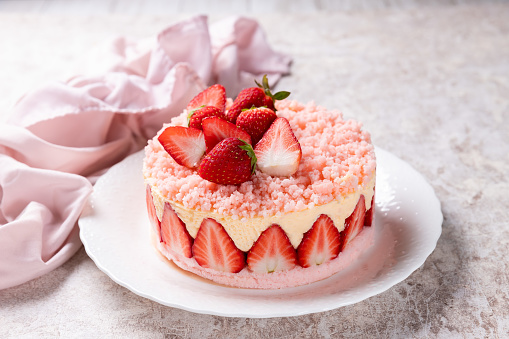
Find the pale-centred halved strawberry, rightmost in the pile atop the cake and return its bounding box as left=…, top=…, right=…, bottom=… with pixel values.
left=254, top=118, right=302, bottom=176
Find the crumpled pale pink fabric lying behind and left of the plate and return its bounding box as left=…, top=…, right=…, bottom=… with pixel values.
left=0, top=16, right=290, bottom=289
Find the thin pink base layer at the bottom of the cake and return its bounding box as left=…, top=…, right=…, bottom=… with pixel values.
left=157, top=225, right=375, bottom=289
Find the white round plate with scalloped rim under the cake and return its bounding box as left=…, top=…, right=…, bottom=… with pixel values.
left=79, top=148, right=443, bottom=318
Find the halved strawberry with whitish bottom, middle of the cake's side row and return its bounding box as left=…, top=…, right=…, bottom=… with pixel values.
left=247, top=224, right=297, bottom=273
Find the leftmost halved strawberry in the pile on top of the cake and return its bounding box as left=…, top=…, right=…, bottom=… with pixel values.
left=158, top=126, right=206, bottom=168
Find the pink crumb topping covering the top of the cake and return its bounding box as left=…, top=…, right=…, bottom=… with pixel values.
left=144, top=100, right=376, bottom=218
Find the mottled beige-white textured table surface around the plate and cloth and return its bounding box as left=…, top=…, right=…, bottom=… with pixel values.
left=0, top=2, right=509, bottom=338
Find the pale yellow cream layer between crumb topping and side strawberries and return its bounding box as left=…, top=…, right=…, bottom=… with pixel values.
left=152, top=175, right=375, bottom=252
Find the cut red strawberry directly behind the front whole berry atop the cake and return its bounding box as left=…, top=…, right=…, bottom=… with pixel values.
left=202, top=117, right=251, bottom=153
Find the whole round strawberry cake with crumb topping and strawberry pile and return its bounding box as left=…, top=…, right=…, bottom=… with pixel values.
left=143, top=77, right=376, bottom=289
